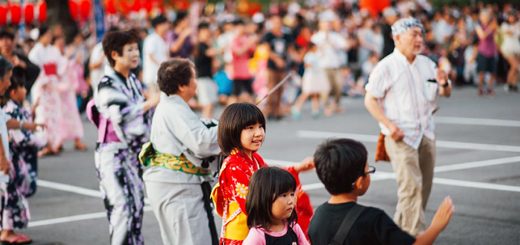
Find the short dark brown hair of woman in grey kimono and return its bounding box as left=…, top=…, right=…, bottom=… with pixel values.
left=157, top=58, right=195, bottom=95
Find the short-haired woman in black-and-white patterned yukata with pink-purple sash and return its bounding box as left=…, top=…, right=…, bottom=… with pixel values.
left=91, top=31, right=159, bottom=244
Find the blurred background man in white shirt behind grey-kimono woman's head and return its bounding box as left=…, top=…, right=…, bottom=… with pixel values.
left=143, top=15, right=170, bottom=92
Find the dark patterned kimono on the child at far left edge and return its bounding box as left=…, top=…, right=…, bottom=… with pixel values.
left=3, top=100, right=39, bottom=197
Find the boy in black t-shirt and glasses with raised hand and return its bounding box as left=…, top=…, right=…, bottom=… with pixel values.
left=309, top=139, right=454, bottom=245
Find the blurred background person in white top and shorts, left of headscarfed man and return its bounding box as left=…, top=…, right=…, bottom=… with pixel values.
left=311, top=11, right=347, bottom=115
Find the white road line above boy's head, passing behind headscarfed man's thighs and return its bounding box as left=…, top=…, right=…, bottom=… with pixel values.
left=297, top=130, right=520, bottom=152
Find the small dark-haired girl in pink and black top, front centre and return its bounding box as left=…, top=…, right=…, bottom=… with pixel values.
left=242, top=167, right=310, bottom=245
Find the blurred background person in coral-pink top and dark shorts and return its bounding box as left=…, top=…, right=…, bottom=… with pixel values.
left=229, top=19, right=257, bottom=104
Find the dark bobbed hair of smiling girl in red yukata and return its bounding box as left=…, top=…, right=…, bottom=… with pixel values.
left=218, top=103, right=266, bottom=155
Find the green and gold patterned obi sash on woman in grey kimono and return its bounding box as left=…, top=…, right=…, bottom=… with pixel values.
left=139, top=142, right=211, bottom=176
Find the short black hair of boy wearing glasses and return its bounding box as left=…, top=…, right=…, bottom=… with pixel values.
left=314, top=139, right=368, bottom=195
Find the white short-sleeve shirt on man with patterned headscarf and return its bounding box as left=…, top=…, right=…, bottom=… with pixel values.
left=366, top=49, right=439, bottom=149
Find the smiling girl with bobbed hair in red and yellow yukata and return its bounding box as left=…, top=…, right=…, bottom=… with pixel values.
left=212, top=103, right=314, bottom=244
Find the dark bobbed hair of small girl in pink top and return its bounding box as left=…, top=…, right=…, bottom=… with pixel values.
left=246, top=167, right=298, bottom=229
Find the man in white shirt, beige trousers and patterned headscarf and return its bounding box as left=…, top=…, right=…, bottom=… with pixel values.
left=365, top=18, right=451, bottom=236
